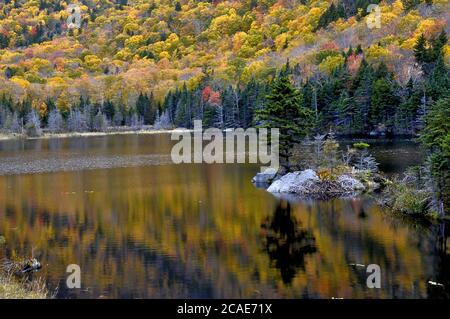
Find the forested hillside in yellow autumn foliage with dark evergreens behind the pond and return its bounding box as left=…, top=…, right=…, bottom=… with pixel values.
left=0, top=0, right=450, bottom=134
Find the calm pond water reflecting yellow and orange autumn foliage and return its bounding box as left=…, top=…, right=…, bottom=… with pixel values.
left=0, top=135, right=449, bottom=298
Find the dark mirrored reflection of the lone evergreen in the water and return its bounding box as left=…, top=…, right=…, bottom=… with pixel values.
left=261, top=200, right=317, bottom=284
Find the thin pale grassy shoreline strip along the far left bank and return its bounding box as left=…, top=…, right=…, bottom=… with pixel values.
left=0, top=128, right=191, bottom=141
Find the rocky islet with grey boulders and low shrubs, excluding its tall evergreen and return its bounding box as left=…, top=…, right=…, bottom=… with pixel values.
left=253, top=138, right=388, bottom=200
